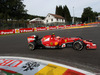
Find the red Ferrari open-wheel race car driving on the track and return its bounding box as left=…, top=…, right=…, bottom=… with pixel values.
left=27, top=35, right=97, bottom=51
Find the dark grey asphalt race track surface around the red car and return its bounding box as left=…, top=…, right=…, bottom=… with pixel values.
left=0, top=25, right=100, bottom=73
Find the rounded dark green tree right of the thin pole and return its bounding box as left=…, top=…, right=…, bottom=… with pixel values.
left=81, top=7, right=95, bottom=23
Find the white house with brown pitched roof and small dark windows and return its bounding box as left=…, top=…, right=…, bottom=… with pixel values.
left=44, top=13, right=65, bottom=24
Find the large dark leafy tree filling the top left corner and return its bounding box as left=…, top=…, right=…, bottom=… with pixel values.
left=0, top=0, right=27, bottom=20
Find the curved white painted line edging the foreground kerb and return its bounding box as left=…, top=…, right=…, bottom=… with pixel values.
left=0, top=56, right=95, bottom=75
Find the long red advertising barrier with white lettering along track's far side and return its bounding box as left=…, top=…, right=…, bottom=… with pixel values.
left=0, top=22, right=100, bottom=35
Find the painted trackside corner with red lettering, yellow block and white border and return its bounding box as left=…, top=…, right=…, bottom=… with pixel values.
left=0, top=56, right=94, bottom=75
